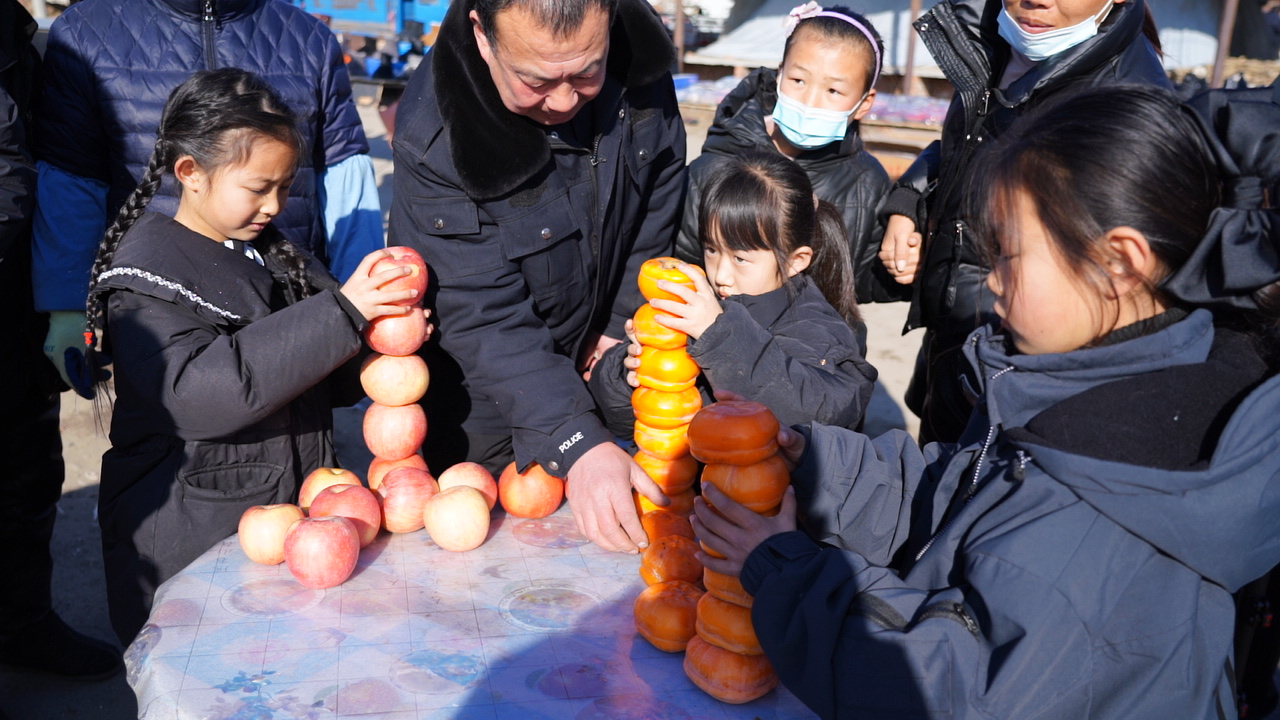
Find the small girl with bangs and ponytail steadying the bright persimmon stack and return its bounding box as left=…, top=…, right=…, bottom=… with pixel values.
left=590, top=151, right=876, bottom=437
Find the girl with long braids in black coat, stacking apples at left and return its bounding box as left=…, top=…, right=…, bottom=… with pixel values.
left=86, top=69, right=413, bottom=644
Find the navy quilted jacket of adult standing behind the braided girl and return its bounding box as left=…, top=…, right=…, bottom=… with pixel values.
left=38, top=0, right=369, bottom=259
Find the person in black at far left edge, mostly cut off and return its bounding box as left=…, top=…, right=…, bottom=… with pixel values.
left=0, top=0, right=122, bottom=681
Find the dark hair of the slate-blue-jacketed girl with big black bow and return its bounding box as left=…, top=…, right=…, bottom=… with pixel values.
left=969, top=86, right=1280, bottom=359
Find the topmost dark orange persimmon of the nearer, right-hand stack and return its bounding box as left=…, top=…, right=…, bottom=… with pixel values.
left=689, top=400, right=778, bottom=465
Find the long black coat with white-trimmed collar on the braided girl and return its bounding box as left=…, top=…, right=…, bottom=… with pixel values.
left=96, top=213, right=364, bottom=644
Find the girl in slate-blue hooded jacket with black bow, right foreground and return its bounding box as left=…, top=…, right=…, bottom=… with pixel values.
left=694, top=88, right=1280, bottom=720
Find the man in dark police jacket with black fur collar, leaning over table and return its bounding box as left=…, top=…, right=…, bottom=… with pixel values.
left=389, top=0, right=685, bottom=552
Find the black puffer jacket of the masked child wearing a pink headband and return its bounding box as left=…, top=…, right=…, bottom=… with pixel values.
left=676, top=68, right=910, bottom=302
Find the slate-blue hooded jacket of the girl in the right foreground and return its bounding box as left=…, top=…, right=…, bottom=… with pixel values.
left=742, top=310, right=1280, bottom=720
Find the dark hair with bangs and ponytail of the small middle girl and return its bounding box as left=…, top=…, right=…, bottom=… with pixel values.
left=698, top=149, right=861, bottom=325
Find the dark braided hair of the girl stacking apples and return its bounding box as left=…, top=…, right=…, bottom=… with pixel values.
left=84, top=68, right=311, bottom=345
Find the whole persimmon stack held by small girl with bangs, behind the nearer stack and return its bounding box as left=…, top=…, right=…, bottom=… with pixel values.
left=631, top=258, right=703, bottom=652
